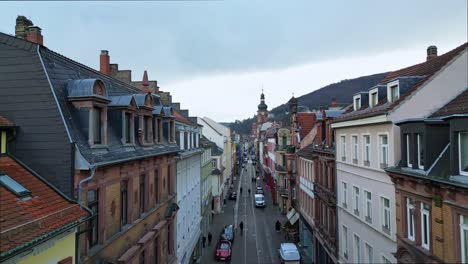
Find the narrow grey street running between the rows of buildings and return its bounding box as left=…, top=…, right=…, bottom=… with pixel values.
left=201, top=160, right=286, bottom=264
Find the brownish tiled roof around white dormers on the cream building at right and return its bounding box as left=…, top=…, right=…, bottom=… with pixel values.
left=334, top=42, right=468, bottom=123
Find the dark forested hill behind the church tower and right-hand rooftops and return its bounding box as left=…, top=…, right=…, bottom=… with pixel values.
left=228, top=73, right=387, bottom=135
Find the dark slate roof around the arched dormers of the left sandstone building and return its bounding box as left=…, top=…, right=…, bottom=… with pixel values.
left=0, top=33, right=179, bottom=164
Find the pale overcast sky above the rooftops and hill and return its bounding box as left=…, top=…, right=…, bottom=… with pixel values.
left=0, top=0, right=468, bottom=121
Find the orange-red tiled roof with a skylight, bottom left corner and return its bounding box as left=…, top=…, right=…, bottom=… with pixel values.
left=0, top=156, right=88, bottom=257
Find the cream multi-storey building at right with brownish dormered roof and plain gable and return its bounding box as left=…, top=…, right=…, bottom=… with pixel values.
left=332, top=44, right=467, bottom=263
